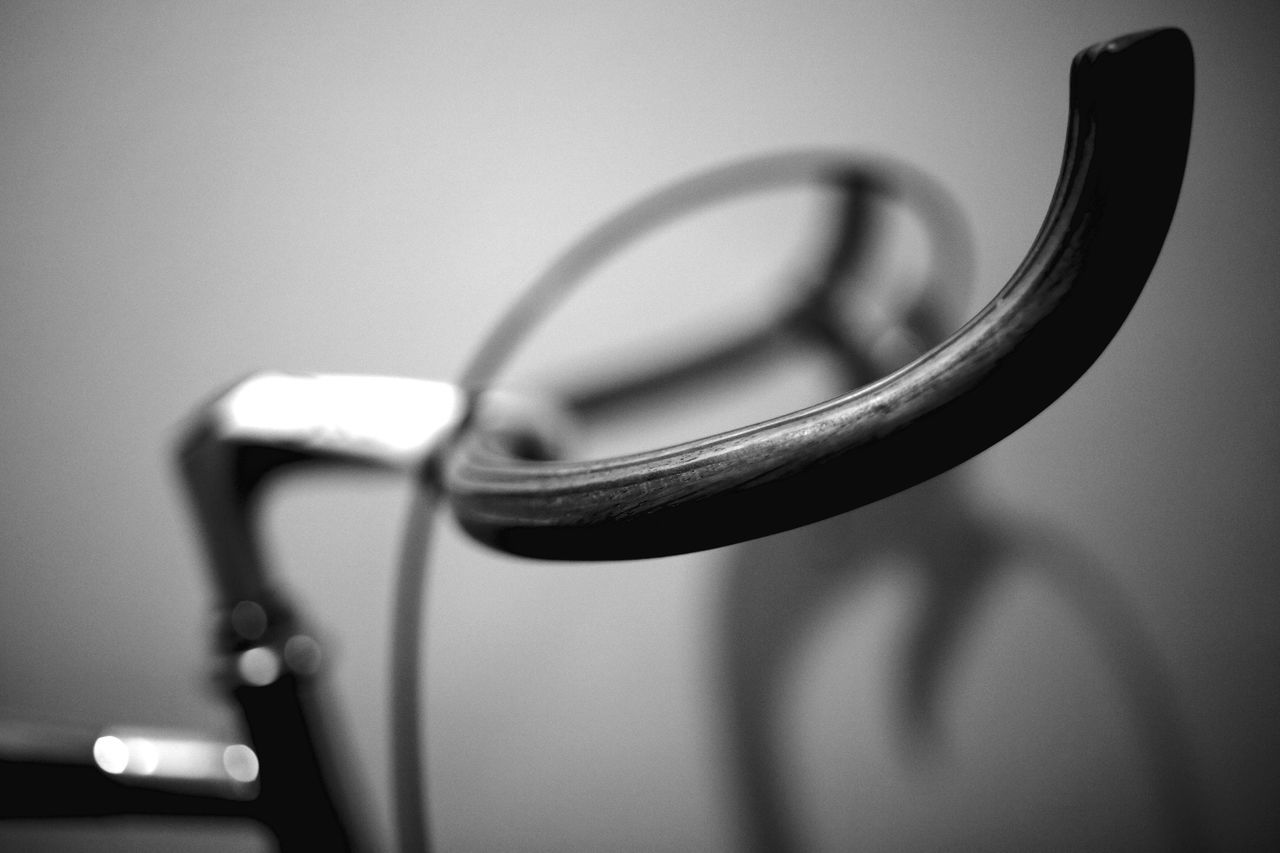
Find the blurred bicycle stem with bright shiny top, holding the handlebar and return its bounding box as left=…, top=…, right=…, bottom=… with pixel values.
left=177, top=371, right=564, bottom=610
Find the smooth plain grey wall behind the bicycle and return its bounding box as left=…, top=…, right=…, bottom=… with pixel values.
left=0, top=0, right=1280, bottom=850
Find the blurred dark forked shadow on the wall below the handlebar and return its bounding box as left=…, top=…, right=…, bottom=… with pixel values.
left=714, top=469, right=1208, bottom=853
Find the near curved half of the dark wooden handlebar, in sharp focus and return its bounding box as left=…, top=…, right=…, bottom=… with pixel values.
left=445, top=29, right=1194, bottom=560
